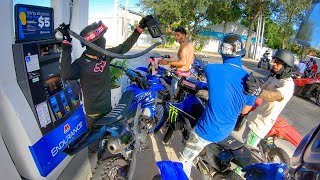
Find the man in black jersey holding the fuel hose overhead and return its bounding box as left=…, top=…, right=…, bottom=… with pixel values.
left=59, top=16, right=150, bottom=152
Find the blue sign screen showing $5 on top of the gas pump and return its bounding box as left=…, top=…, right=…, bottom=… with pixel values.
left=14, top=4, right=54, bottom=42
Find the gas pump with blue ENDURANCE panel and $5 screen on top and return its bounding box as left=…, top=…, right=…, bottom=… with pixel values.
left=4, top=4, right=86, bottom=179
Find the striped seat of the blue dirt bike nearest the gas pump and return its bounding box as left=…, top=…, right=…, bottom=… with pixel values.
left=94, top=91, right=134, bottom=126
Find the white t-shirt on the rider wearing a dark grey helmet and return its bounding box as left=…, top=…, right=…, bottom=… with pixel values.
left=247, top=76, right=294, bottom=138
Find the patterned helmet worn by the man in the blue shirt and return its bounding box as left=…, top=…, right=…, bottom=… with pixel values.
left=219, top=33, right=246, bottom=57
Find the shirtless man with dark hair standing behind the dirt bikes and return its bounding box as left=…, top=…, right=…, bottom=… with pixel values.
left=159, top=26, right=194, bottom=98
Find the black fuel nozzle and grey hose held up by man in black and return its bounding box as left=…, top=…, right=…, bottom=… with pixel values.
left=54, top=15, right=166, bottom=59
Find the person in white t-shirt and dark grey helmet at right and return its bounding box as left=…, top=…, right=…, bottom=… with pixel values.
left=242, top=49, right=294, bottom=147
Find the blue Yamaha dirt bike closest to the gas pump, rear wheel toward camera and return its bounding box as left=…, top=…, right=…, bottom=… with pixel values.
left=63, top=65, right=169, bottom=179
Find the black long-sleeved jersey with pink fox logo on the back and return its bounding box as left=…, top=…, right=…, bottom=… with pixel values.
left=61, top=30, right=140, bottom=114
